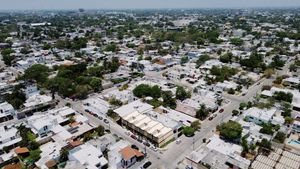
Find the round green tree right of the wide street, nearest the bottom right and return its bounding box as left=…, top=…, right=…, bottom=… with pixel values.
left=218, top=121, right=243, bottom=141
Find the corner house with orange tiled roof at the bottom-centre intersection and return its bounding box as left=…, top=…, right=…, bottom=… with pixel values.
left=120, top=146, right=144, bottom=168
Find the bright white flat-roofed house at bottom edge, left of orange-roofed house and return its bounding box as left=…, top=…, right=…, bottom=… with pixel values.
left=69, top=143, right=108, bottom=169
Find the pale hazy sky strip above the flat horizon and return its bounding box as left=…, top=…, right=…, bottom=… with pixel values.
left=0, top=0, right=300, bottom=10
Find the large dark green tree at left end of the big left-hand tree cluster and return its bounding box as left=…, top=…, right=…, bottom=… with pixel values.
left=23, top=64, right=49, bottom=83
